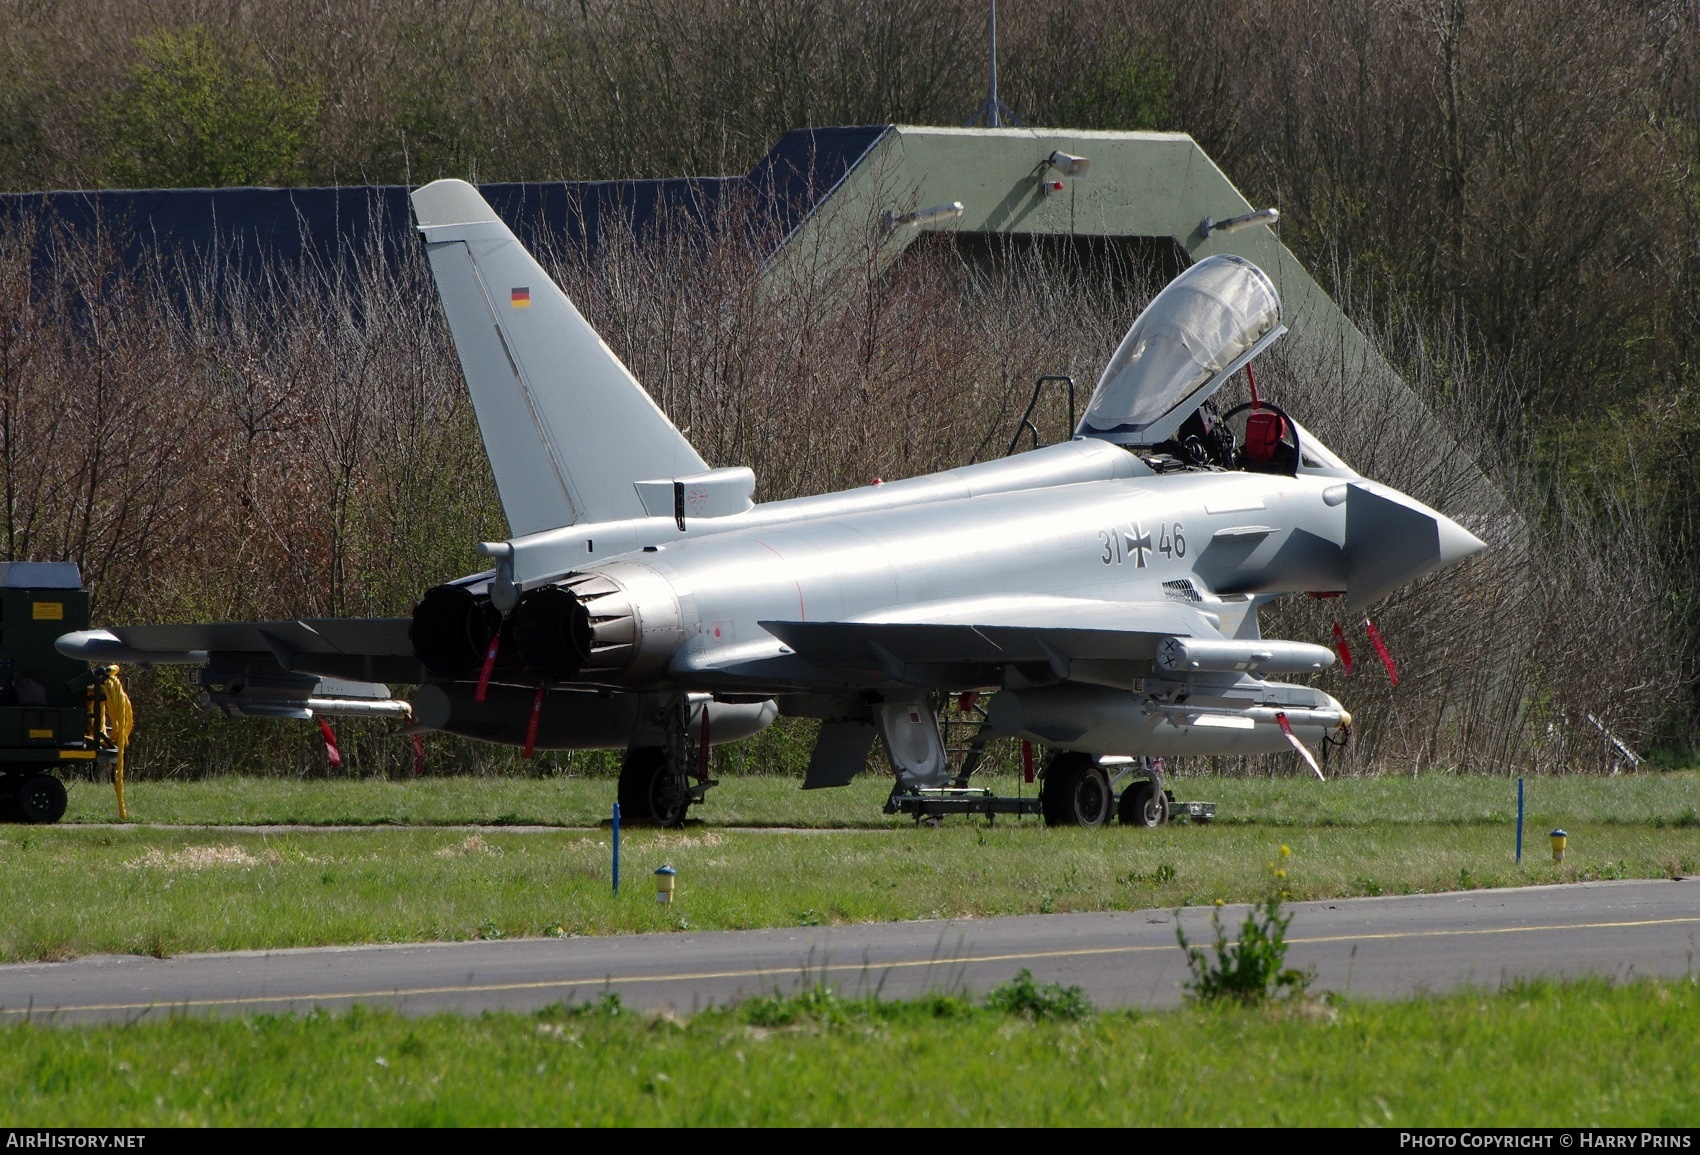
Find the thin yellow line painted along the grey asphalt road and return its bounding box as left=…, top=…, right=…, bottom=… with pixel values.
left=0, top=915, right=1700, bottom=1016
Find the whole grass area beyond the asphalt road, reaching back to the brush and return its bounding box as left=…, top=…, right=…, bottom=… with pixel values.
left=0, top=772, right=1700, bottom=961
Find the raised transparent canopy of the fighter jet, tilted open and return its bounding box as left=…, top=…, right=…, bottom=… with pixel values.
left=1074, top=253, right=1287, bottom=446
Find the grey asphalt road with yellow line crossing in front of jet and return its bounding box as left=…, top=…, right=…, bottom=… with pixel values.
left=0, top=879, right=1700, bottom=1022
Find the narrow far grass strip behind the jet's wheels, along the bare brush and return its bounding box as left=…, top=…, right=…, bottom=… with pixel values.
left=65, top=771, right=1700, bottom=834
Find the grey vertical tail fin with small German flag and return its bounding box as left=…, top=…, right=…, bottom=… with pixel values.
left=411, top=180, right=707, bottom=536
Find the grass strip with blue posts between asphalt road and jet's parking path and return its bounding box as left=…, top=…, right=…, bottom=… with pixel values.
left=0, top=803, right=1700, bottom=961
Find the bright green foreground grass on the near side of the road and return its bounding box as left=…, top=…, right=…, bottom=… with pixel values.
left=0, top=981, right=1700, bottom=1128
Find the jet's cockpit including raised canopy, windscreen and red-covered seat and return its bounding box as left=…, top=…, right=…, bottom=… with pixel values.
left=1074, top=253, right=1353, bottom=476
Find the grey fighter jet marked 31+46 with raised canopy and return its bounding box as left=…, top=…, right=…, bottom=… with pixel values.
left=60, top=180, right=1482, bottom=825
